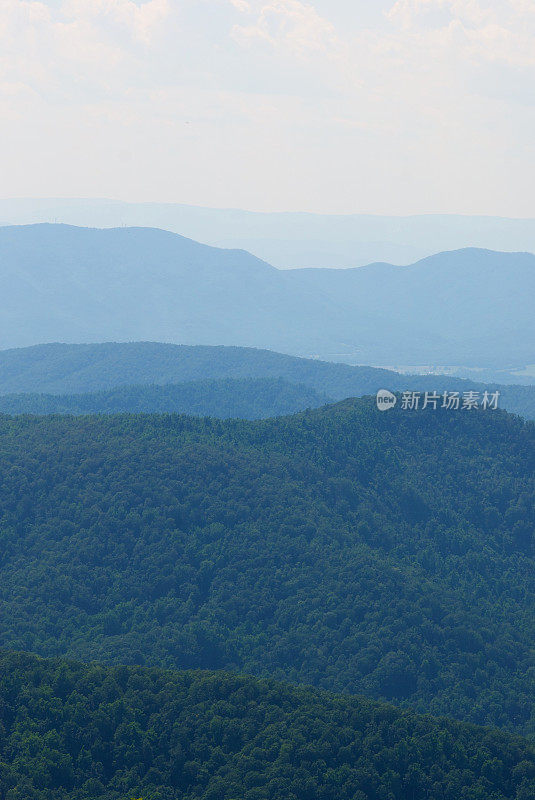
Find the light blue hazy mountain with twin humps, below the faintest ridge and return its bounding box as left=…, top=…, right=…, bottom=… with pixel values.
left=0, top=225, right=535, bottom=368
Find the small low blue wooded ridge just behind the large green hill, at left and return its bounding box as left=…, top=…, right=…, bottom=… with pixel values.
left=0, top=378, right=330, bottom=419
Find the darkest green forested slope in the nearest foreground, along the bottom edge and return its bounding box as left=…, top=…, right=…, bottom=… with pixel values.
left=0, top=654, right=535, bottom=800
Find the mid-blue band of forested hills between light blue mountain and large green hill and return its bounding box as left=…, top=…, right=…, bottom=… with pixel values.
left=0, top=342, right=535, bottom=419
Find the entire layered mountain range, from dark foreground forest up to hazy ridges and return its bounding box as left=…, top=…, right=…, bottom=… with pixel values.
left=0, top=216, right=535, bottom=800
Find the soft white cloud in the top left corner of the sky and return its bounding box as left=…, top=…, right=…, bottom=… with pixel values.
left=0, top=0, right=170, bottom=103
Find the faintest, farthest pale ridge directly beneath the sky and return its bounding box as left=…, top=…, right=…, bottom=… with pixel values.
left=0, top=198, right=535, bottom=269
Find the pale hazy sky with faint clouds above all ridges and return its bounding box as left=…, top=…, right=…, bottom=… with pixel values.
left=0, top=0, right=535, bottom=217
